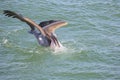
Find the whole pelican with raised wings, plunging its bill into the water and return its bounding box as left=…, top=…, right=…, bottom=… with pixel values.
left=3, top=10, right=67, bottom=49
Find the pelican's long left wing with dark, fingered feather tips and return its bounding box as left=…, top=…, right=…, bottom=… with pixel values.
left=4, top=10, right=46, bottom=36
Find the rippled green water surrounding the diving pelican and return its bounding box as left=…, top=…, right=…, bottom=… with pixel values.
left=0, top=0, right=120, bottom=80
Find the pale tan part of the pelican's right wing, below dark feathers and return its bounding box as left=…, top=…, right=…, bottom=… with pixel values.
left=44, top=21, right=67, bottom=35
